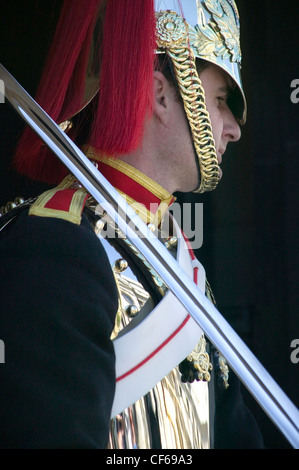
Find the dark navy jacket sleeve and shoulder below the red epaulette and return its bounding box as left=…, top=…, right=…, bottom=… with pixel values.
left=0, top=211, right=118, bottom=449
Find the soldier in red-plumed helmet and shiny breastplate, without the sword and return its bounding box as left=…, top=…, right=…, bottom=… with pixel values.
left=0, top=0, right=262, bottom=449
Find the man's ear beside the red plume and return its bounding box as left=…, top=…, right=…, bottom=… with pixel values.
left=153, top=70, right=174, bottom=121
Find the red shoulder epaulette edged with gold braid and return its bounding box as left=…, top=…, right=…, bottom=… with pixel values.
left=29, top=175, right=88, bottom=225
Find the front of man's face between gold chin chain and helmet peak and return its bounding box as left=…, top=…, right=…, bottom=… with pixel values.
left=200, top=65, right=241, bottom=175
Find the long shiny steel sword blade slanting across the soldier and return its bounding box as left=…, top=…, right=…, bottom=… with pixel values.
left=0, top=64, right=299, bottom=449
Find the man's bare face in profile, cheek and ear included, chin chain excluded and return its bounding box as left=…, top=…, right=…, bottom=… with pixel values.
left=150, top=65, right=241, bottom=192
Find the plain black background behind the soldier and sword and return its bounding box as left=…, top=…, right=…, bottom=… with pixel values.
left=0, top=0, right=299, bottom=448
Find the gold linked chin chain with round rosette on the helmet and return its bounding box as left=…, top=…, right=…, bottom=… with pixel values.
left=156, top=12, right=220, bottom=193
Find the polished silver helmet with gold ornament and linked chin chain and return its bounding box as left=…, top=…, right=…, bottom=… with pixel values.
left=155, top=0, right=246, bottom=193
